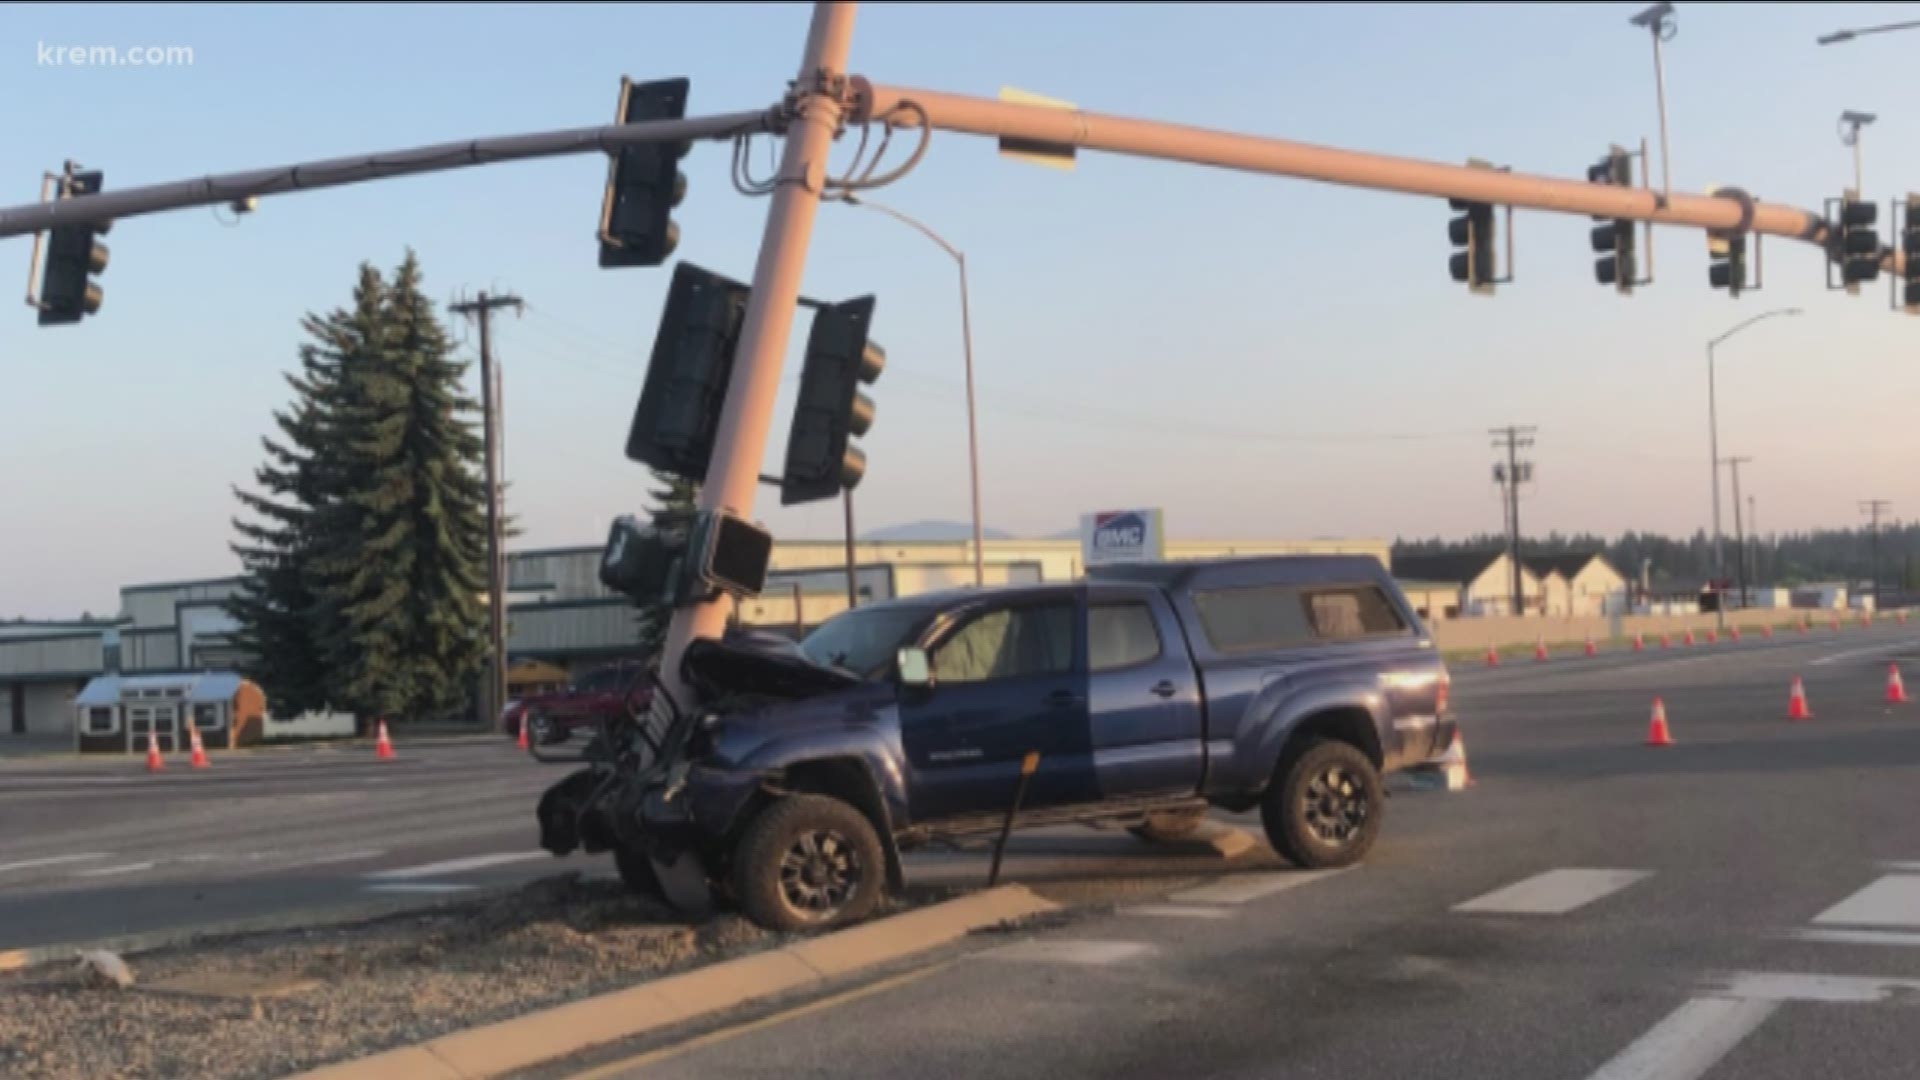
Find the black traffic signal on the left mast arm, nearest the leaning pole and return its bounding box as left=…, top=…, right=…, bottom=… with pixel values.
left=599, top=79, right=689, bottom=267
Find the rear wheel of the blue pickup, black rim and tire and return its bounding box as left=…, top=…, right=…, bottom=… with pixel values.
left=1260, top=738, right=1386, bottom=871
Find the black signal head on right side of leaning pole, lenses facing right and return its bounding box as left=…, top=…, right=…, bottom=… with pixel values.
left=780, top=296, right=887, bottom=505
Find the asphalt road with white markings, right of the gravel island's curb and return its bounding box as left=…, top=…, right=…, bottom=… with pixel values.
left=541, top=626, right=1920, bottom=1080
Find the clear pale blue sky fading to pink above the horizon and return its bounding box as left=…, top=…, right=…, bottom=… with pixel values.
left=0, top=4, right=1920, bottom=617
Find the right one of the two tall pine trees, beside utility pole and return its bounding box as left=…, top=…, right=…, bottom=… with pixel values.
left=315, top=252, right=486, bottom=719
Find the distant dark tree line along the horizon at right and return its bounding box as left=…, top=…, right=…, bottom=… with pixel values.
left=1394, top=523, right=1920, bottom=588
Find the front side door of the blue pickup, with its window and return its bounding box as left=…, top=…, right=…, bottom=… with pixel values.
left=900, top=594, right=1098, bottom=822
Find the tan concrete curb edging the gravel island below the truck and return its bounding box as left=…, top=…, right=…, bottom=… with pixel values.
left=292, top=886, right=1058, bottom=1080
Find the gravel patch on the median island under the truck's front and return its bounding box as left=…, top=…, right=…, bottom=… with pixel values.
left=0, top=874, right=802, bottom=1080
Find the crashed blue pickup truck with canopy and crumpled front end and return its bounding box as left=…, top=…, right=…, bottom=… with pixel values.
left=540, top=555, right=1453, bottom=930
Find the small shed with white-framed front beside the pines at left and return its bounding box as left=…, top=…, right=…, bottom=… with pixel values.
left=73, top=671, right=267, bottom=753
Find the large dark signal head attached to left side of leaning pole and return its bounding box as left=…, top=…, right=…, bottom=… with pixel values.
left=626, top=263, right=753, bottom=480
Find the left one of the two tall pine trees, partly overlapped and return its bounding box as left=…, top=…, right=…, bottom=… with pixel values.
left=228, top=265, right=386, bottom=715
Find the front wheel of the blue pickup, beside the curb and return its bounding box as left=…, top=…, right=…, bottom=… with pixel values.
left=733, top=796, right=887, bottom=930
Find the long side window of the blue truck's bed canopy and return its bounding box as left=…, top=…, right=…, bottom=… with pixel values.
left=1194, top=584, right=1407, bottom=653
